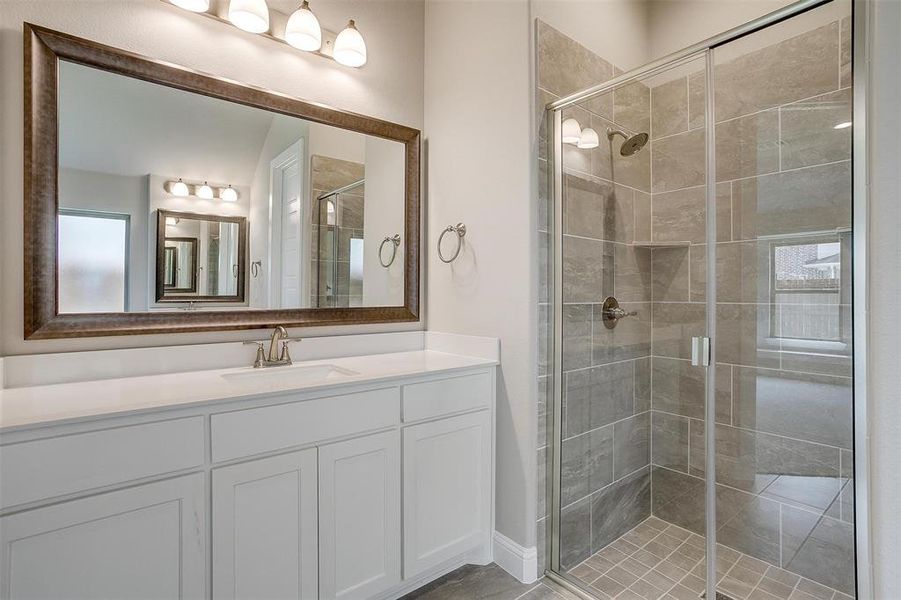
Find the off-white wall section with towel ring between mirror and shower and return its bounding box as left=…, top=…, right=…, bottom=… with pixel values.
left=425, top=0, right=537, bottom=546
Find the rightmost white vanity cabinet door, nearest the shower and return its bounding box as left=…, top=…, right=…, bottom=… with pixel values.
left=403, top=411, right=491, bottom=578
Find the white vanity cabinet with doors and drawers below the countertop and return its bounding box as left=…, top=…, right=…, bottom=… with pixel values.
left=0, top=365, right=495, bottom=600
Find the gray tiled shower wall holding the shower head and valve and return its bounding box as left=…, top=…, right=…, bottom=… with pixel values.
left=536, top=21, right=653, bottom=570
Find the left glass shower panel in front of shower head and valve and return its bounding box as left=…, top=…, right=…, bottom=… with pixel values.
left=549, top=53, right=712, bottom=598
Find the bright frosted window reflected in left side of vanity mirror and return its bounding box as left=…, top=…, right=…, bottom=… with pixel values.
left=58, top=209, right=129, bottom=313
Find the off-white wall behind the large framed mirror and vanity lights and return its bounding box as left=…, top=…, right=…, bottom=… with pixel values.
left=0, top=0, right=424, bottom=354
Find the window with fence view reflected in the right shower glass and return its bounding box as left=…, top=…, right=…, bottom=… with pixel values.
left=770, top=240, right=843, bottom=341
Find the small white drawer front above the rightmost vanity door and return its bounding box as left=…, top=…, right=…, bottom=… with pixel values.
left=404, top=372, right=491, bottom=421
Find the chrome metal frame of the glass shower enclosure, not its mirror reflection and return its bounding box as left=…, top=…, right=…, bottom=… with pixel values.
left=544, top=0, right=873, bottom=600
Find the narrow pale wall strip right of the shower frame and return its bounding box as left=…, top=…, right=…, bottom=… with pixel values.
left=867, top=0, right=901, bottom=600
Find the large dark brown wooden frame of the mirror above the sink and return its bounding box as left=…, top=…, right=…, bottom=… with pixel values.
left=24, top=23, right=420, bottom=340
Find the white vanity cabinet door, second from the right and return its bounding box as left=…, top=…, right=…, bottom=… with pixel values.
left=319, top=431, right=400, bottom=599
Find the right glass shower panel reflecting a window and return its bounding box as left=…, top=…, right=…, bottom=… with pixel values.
left=712, top=2, right=855, bottom=598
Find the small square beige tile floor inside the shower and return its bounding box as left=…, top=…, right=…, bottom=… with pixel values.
left=569, top=517, right=852, bottom=600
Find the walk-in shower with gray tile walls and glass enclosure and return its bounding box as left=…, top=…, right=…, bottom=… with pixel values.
left=538, top=0, right=858, bottom=600
